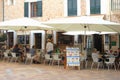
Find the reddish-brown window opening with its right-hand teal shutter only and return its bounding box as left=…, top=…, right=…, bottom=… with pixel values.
left=31, top=1, right=42, bottom=17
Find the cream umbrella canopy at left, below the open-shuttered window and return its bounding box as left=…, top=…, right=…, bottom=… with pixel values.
left=0, top=17, right=53, bottom=31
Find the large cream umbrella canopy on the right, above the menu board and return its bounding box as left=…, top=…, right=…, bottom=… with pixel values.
left=44, top=16, right=120, bottom=32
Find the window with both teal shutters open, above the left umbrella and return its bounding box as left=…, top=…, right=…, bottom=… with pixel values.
left=24, top=0, right=42, bottom=17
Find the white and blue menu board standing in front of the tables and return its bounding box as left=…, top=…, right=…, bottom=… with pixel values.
left=66, top=47, right=80, bottom=66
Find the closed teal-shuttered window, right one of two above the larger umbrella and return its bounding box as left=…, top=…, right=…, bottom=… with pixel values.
left=90, top=0, right=101, bottom=14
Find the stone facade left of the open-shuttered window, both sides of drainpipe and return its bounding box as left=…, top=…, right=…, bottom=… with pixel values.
left=0, top=0, right=24, bottom=20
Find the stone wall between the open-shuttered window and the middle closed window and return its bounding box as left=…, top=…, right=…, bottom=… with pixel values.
left=43, top=0, right=64, bottom=19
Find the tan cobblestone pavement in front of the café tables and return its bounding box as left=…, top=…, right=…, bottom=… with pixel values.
left=0, top=61, right=120, bottom=80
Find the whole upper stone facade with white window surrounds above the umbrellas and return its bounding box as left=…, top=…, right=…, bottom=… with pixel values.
left=0, top=0, right=120, bottom=51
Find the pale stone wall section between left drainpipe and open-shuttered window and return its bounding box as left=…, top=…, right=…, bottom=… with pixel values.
left=4, top=0, right=24, bottom=20
